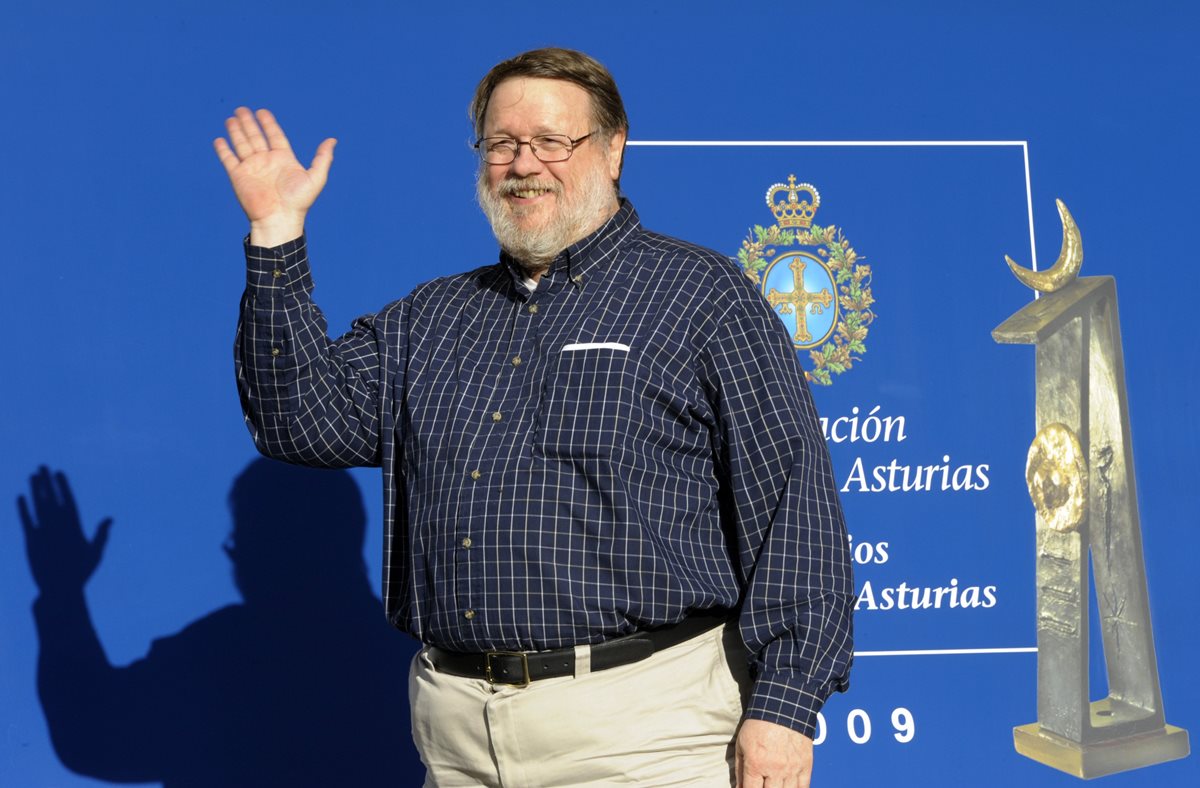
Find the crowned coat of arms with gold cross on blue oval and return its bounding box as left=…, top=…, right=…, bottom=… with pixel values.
left=737, top=175, right=875, bottom=385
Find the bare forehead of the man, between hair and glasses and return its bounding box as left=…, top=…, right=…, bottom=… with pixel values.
left=484, top=77, right=592, bottom=134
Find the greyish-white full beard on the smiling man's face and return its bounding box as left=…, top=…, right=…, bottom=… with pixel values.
left=475, top=158, right=616, bottom=272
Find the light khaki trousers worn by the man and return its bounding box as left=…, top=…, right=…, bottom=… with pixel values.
left=408, top=626, right=750, bottom=788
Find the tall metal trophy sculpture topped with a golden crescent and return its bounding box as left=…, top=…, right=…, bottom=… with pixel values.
left=991, top=200, right=1188, bottom=777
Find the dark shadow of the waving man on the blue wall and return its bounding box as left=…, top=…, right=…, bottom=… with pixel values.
left=18, top=459, right=424, bottom=788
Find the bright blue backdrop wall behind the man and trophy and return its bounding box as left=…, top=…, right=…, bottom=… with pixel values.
left=0, top=0, right=1200, bottom=788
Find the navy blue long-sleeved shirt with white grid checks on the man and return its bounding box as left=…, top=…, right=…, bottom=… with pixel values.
left=236, top=201, right=854, bottom=735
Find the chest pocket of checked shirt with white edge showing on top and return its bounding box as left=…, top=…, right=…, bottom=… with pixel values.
left=534, top=343, right=635, bottom=459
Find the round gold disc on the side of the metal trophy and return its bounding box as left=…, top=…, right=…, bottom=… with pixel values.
left=1025, top=423, right=1087, bottom=531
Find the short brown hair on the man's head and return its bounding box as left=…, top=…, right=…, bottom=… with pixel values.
left=469, top=47, right=629, bottom=179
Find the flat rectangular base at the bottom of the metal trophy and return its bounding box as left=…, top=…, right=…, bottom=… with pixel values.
left=1013, top=722, right=1189, bottom=780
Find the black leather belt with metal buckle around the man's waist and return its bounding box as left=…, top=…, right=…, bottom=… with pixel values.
left=428, top=609, right=731, bottom=686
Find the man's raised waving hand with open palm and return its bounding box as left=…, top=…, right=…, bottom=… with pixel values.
left=212, top=107, right=337, bottom=246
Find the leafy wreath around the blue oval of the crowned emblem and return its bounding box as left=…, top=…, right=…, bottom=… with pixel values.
left=738, top=224, right=875, bottom=386
